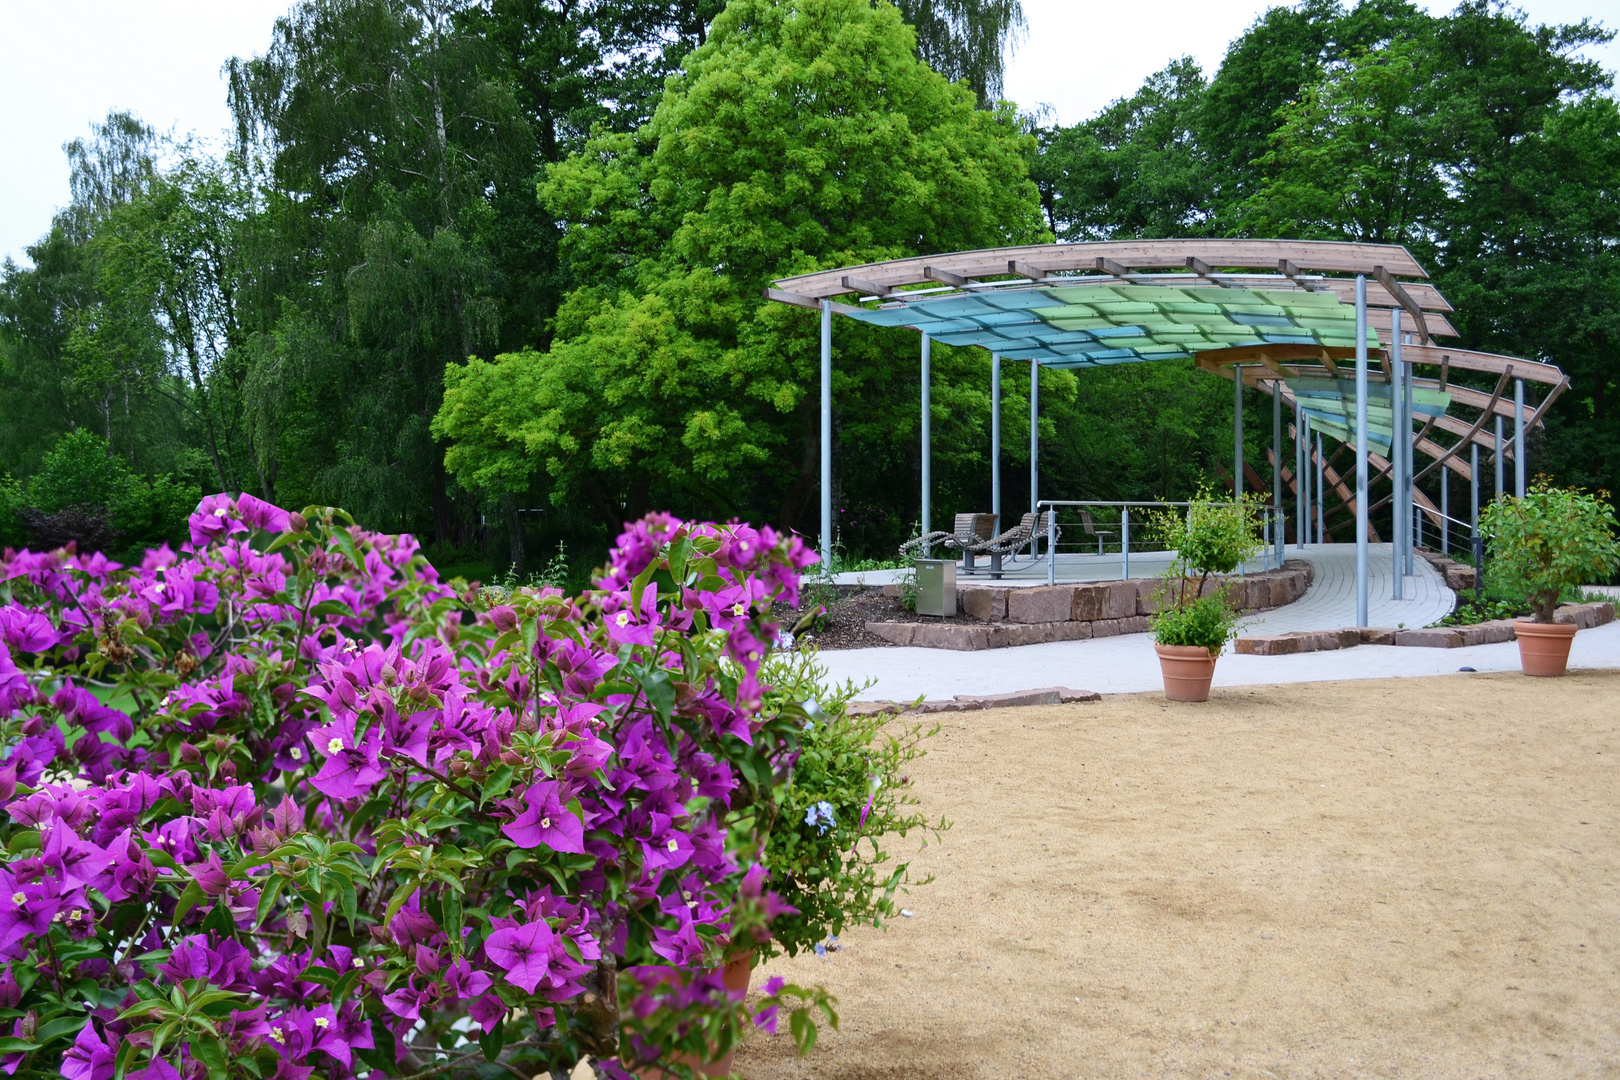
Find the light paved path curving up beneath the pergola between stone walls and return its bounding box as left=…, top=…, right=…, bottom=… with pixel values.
left=1243, top=544, right=1456, bottom=633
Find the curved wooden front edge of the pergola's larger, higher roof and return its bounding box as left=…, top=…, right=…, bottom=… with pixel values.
left=776, top=240, right=1429, bottom=298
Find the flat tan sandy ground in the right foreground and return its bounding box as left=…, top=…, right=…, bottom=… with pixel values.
left=737, top=672, right=1620, bottom=1080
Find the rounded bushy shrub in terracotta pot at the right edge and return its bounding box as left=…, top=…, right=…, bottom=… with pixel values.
left=1479, top=478, right=1620, bottom=675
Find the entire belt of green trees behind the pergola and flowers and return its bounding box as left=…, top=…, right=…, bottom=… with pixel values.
left=0, top=0, right=1620, bottom=576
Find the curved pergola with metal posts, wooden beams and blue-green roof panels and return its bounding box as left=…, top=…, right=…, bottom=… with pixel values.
left=765, top=240, right=1570, bottom=625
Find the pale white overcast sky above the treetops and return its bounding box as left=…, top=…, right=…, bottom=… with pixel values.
left=0, top=0, right=1620, bottom=259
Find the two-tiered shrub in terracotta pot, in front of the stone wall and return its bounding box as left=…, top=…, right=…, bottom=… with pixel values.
left=1152, top=487, right=1260, bottom=701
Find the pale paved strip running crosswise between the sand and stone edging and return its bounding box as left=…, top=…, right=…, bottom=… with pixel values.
left=821, top=622, right=1620, bottom=701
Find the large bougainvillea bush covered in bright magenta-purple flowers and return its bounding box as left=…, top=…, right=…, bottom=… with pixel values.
left=0, top=495, right=836, bottom=1080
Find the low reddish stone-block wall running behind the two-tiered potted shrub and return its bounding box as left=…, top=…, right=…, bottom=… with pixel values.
left=867, top=560, right=1314, bottom=651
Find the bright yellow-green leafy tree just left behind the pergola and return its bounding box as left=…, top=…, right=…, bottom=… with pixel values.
left=434, top=0, right=1043, bottom=540
